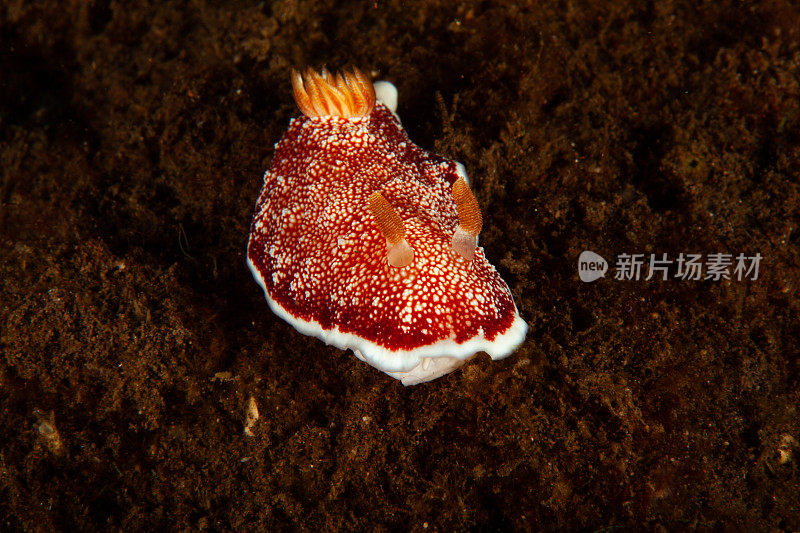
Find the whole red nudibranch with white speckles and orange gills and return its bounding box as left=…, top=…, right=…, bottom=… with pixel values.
left=247, top=69, right=528, bottom=385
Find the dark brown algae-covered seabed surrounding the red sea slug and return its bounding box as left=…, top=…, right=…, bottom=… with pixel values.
left=0, top=0, right=800, bottom=531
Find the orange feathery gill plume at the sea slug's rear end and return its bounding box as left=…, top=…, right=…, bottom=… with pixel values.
left=292, top=67, right=375, bottom=118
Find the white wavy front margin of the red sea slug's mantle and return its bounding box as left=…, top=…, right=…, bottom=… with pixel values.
left=247, top=255, right=528, bottom=385
